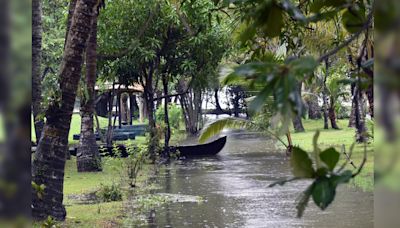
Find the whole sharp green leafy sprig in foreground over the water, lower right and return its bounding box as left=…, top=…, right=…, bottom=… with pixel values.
left=269, top=131, right=366, bottom=218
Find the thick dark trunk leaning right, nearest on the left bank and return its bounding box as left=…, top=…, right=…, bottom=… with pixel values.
left=32, top=0, right=97, bottom=220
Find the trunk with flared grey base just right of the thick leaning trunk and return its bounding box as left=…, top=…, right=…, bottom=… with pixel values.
left=76, top=12, right=101, bottom=172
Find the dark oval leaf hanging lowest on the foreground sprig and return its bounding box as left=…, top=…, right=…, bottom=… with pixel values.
left=312, top=177, right=336, bottom=210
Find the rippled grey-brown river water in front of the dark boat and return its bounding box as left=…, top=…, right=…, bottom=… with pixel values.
left=149, top=133, right=373, bottom=228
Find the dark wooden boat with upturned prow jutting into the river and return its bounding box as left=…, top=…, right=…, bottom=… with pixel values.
left=176, top=136, right=226, bottom=157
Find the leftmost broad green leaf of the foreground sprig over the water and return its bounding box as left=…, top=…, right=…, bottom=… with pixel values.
left=290, top=147, right=315, bottom=178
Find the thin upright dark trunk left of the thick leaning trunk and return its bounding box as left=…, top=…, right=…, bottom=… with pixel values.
left=32, top=0, right=44, bottom=142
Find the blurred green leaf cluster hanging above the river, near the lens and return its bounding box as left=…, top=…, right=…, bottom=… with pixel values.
left=222, top=55, right=318, bottom=131
